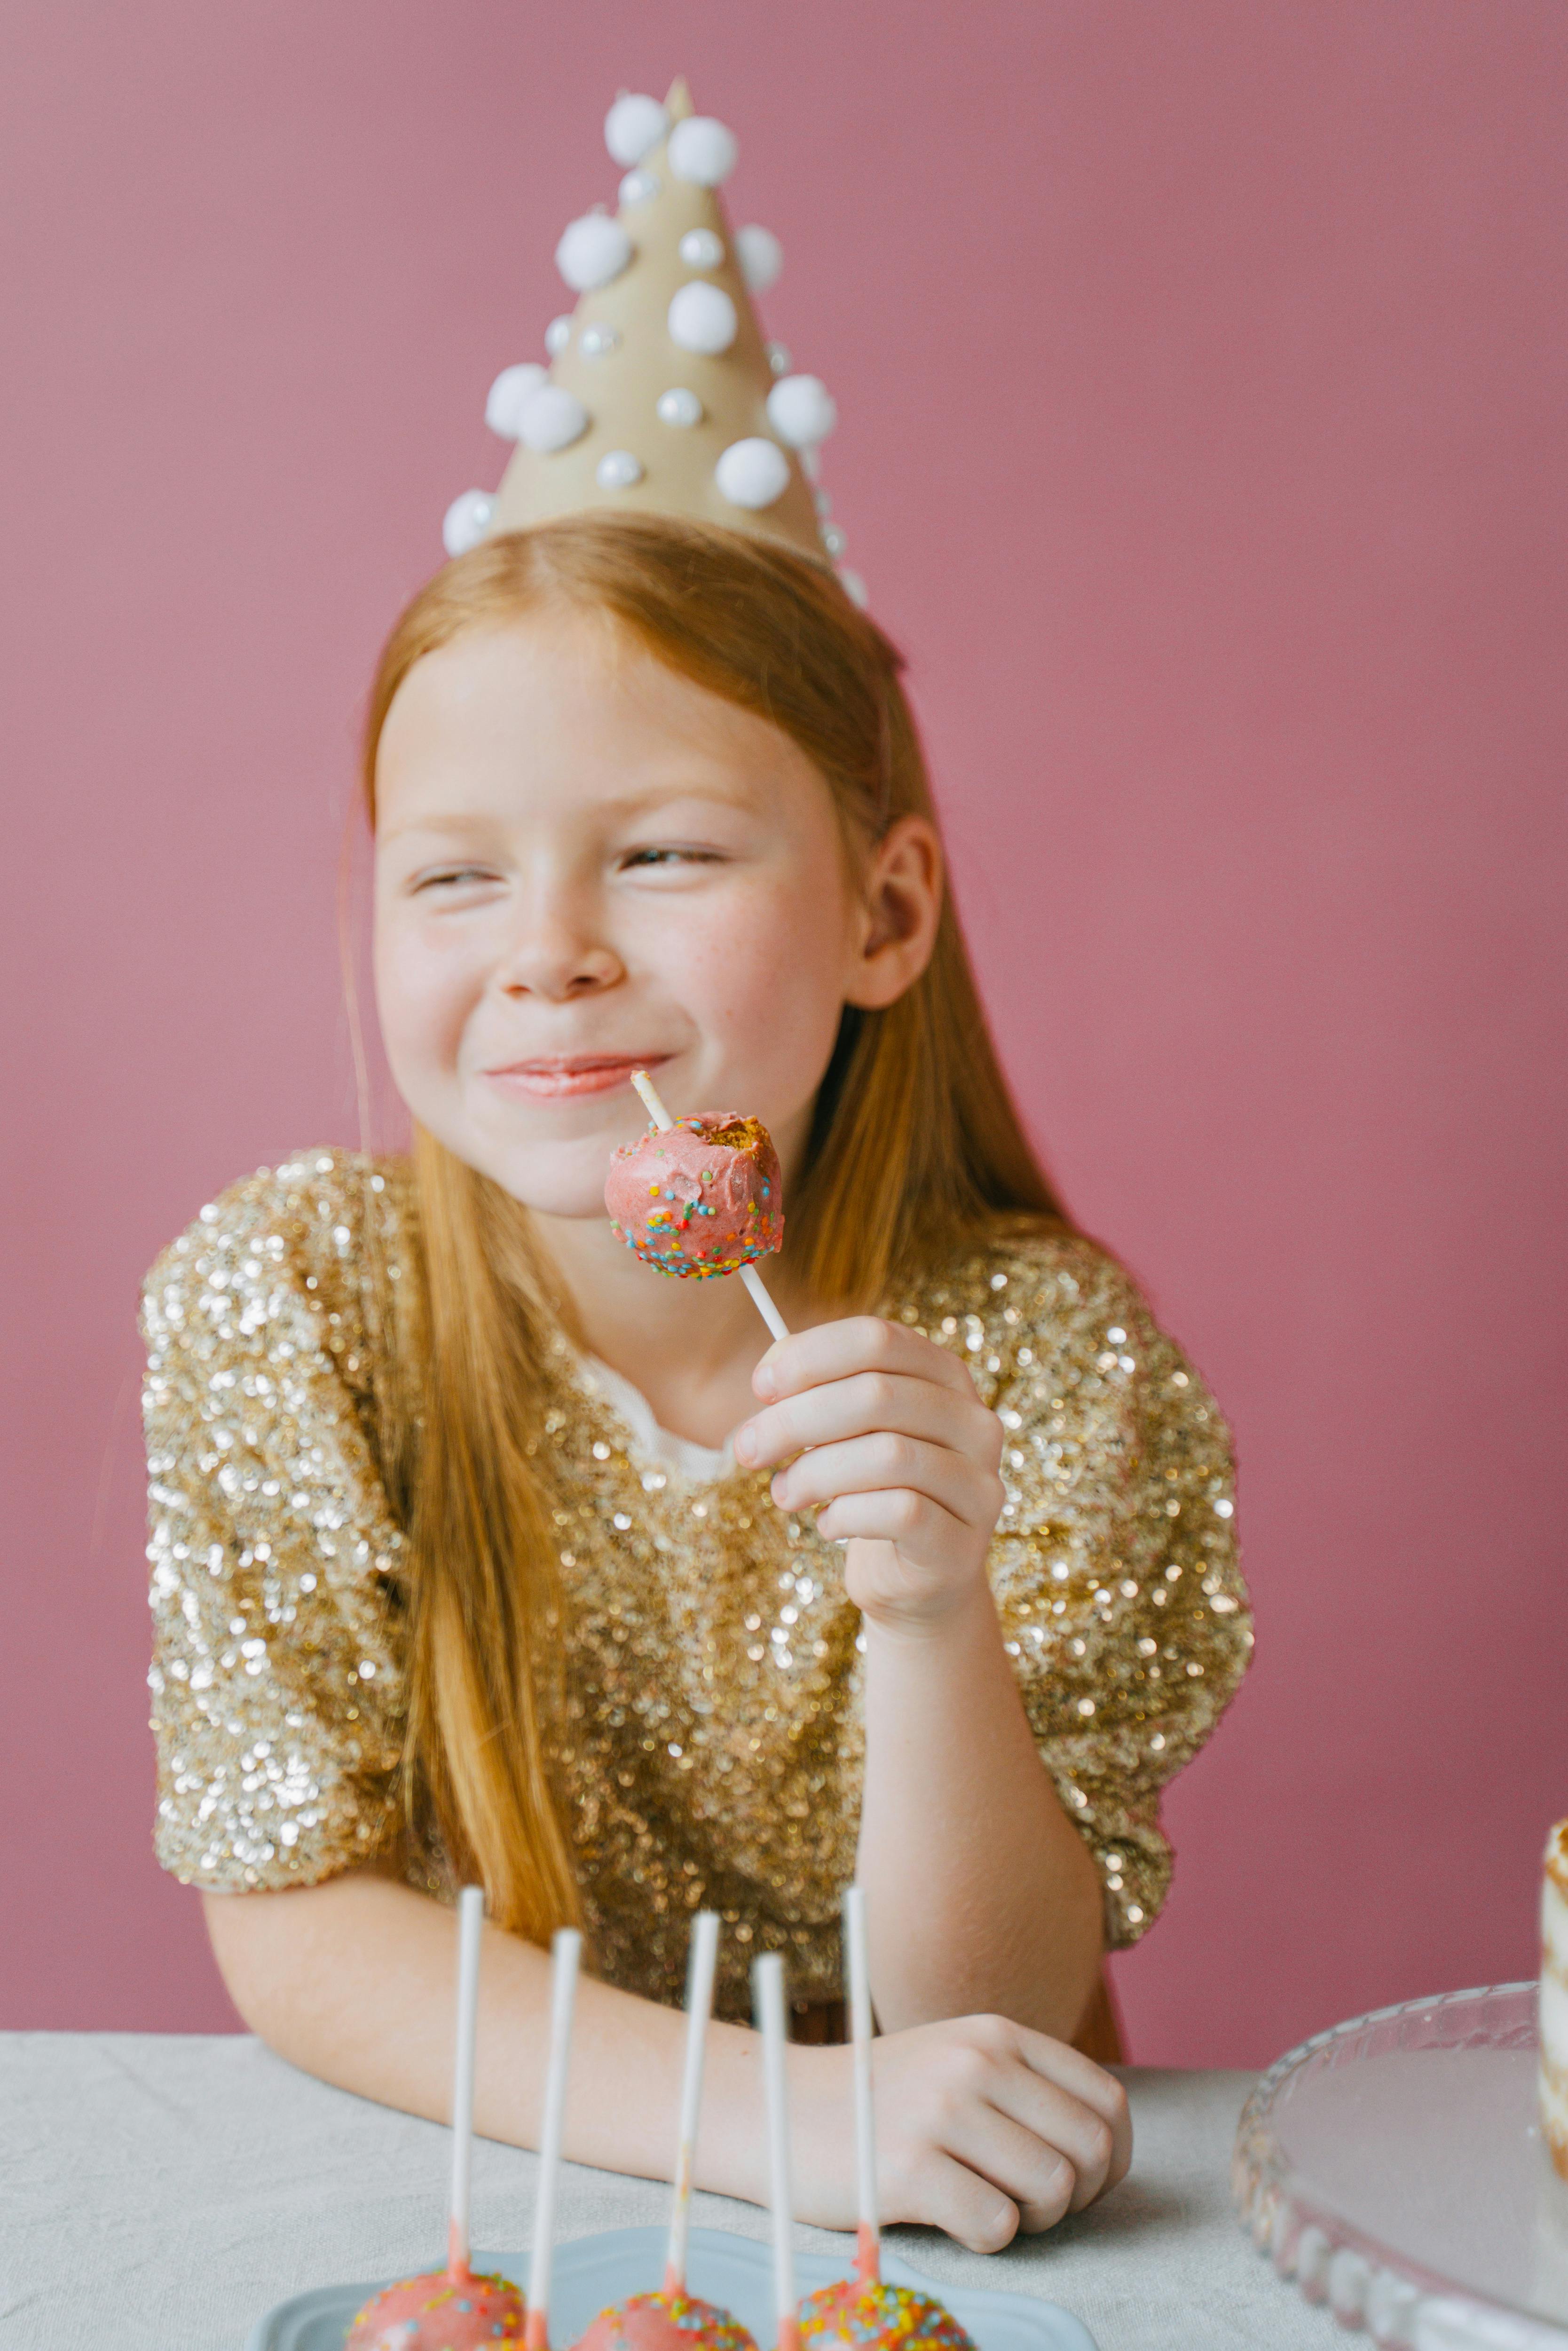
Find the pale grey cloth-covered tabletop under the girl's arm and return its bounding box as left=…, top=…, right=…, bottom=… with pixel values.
left=0, top=2034, right=1345, bottom=2351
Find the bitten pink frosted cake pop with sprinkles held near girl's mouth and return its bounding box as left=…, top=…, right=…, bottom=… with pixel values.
left=604, top=1110, right=783, bottom=1281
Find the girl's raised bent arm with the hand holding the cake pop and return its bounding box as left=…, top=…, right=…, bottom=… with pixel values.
left=736, top=1317, right=1103, bottom=2038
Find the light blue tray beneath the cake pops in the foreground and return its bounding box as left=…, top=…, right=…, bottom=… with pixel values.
left=244, top=2229, right=1095, bottom=2351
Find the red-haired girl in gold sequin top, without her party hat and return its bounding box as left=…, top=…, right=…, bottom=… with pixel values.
left=146, top=513, right=1251, bottom=2250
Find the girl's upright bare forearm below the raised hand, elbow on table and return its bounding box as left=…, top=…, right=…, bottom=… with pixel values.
left=858, top=1587, right=1103, bottom=2038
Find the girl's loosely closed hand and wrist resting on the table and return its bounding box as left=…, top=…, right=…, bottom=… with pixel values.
left=790, top=2017, right=1133, bottom=2252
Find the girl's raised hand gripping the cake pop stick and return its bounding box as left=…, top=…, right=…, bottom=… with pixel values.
left=736, top=1314, right=1001, bottom=1627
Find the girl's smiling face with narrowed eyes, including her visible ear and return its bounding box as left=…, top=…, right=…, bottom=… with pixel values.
left=376, top=611, right=940, bottom=1218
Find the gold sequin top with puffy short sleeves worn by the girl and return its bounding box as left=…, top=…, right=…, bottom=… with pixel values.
left=143, top=1150, right=1253, bottom=2017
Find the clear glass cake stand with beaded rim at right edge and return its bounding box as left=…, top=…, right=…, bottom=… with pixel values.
left=1232, top=1984, right=1568, bottom=2351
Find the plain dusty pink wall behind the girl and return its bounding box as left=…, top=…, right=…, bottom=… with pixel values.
left=0, top=0, right=1568, bottom=2062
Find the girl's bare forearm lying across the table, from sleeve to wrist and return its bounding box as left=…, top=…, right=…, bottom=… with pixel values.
left=207, top=1874, right=804, bottom=2203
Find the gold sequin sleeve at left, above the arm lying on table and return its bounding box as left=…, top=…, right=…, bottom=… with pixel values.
left=141, top=1152, right=411, bottom=1890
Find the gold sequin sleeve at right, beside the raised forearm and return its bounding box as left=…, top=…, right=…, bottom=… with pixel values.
left=943, top=1239, right=1253, bottom=1949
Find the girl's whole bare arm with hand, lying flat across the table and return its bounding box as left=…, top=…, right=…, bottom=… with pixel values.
left=207, top=1871, right=1131, bottom=2252
